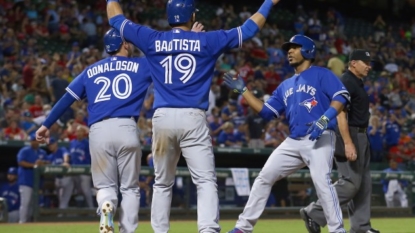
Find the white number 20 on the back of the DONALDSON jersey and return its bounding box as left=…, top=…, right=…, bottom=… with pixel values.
left=94, top=74, right=132, bottom=103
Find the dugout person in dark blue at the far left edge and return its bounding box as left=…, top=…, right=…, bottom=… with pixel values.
left=0, top=167, right=20, bottom=223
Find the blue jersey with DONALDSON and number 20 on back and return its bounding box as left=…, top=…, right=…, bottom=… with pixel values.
left=66, top=56, right=151, bottom=126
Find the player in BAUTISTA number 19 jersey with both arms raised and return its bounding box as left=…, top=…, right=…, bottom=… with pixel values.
left=107, top=0, right=279, bottom=233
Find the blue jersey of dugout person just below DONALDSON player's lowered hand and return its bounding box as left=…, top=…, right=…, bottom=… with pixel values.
left=17, top=146, right=47, bottom=187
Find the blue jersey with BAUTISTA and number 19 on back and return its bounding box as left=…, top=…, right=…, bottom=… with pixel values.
left=119, top=19, right=243, bottom=110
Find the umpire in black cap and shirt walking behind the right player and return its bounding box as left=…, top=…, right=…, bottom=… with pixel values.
left=300, top=49, right=380, bottom=233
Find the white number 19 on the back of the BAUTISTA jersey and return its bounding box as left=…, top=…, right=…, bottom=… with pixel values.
left=160, top=53, right=196, bottom=84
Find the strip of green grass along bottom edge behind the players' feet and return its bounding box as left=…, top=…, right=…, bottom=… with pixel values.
left=0, top=218, right=415, bottom=233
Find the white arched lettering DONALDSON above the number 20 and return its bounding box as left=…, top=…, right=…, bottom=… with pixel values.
left=87, top=61, right=140, bottom=78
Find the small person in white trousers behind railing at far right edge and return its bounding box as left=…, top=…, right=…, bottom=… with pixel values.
left=381, top=160, right=408, bottom=207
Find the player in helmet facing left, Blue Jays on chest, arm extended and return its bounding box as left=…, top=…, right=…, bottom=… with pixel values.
left=225, top=35, right=349, bottom=233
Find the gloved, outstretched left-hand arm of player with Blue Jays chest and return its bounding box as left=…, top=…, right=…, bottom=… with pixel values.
left=224, top=73, right=285, bottom=120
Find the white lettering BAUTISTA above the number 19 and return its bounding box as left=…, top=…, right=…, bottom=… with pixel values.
left=154, top=39, right=200, bottom=52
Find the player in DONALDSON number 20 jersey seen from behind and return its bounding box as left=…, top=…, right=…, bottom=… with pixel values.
left=36, top=29, right=151, bottom=233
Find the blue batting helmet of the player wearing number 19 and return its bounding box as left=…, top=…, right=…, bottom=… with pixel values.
left=167, top=0, right=198, bottom=24
